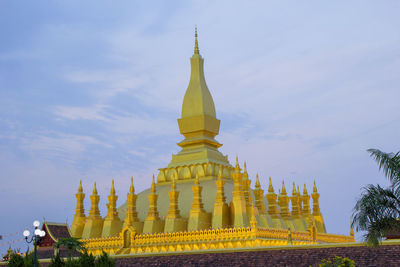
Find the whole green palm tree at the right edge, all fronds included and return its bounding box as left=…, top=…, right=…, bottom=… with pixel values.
left=352, top=149, right=400, bottom=246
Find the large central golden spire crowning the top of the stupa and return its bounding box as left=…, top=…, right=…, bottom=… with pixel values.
left=162, top=28, right=230, bottom=176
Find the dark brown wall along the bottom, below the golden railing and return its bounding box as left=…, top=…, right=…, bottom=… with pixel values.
left=116, top=245, right=400, bottom=267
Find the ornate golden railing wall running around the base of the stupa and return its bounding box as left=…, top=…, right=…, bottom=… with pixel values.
left=81, top=227, right=354, bottom=254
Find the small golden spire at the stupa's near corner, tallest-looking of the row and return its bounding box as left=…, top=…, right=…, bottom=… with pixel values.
left=231, top=157, right=249, bottom=227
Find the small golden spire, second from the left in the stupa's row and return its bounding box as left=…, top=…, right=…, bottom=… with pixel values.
left=82, top=182, right=104, bottom=238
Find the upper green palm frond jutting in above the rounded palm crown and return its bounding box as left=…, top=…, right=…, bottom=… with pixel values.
left=367, top=148, right=400, bottom=183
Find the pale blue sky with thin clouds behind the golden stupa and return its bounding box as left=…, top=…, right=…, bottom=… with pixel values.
left=0, top=0, right=400, bottom=253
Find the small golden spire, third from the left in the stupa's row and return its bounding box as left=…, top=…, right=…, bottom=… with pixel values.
left=101, top=179, right=122, bottom=237
